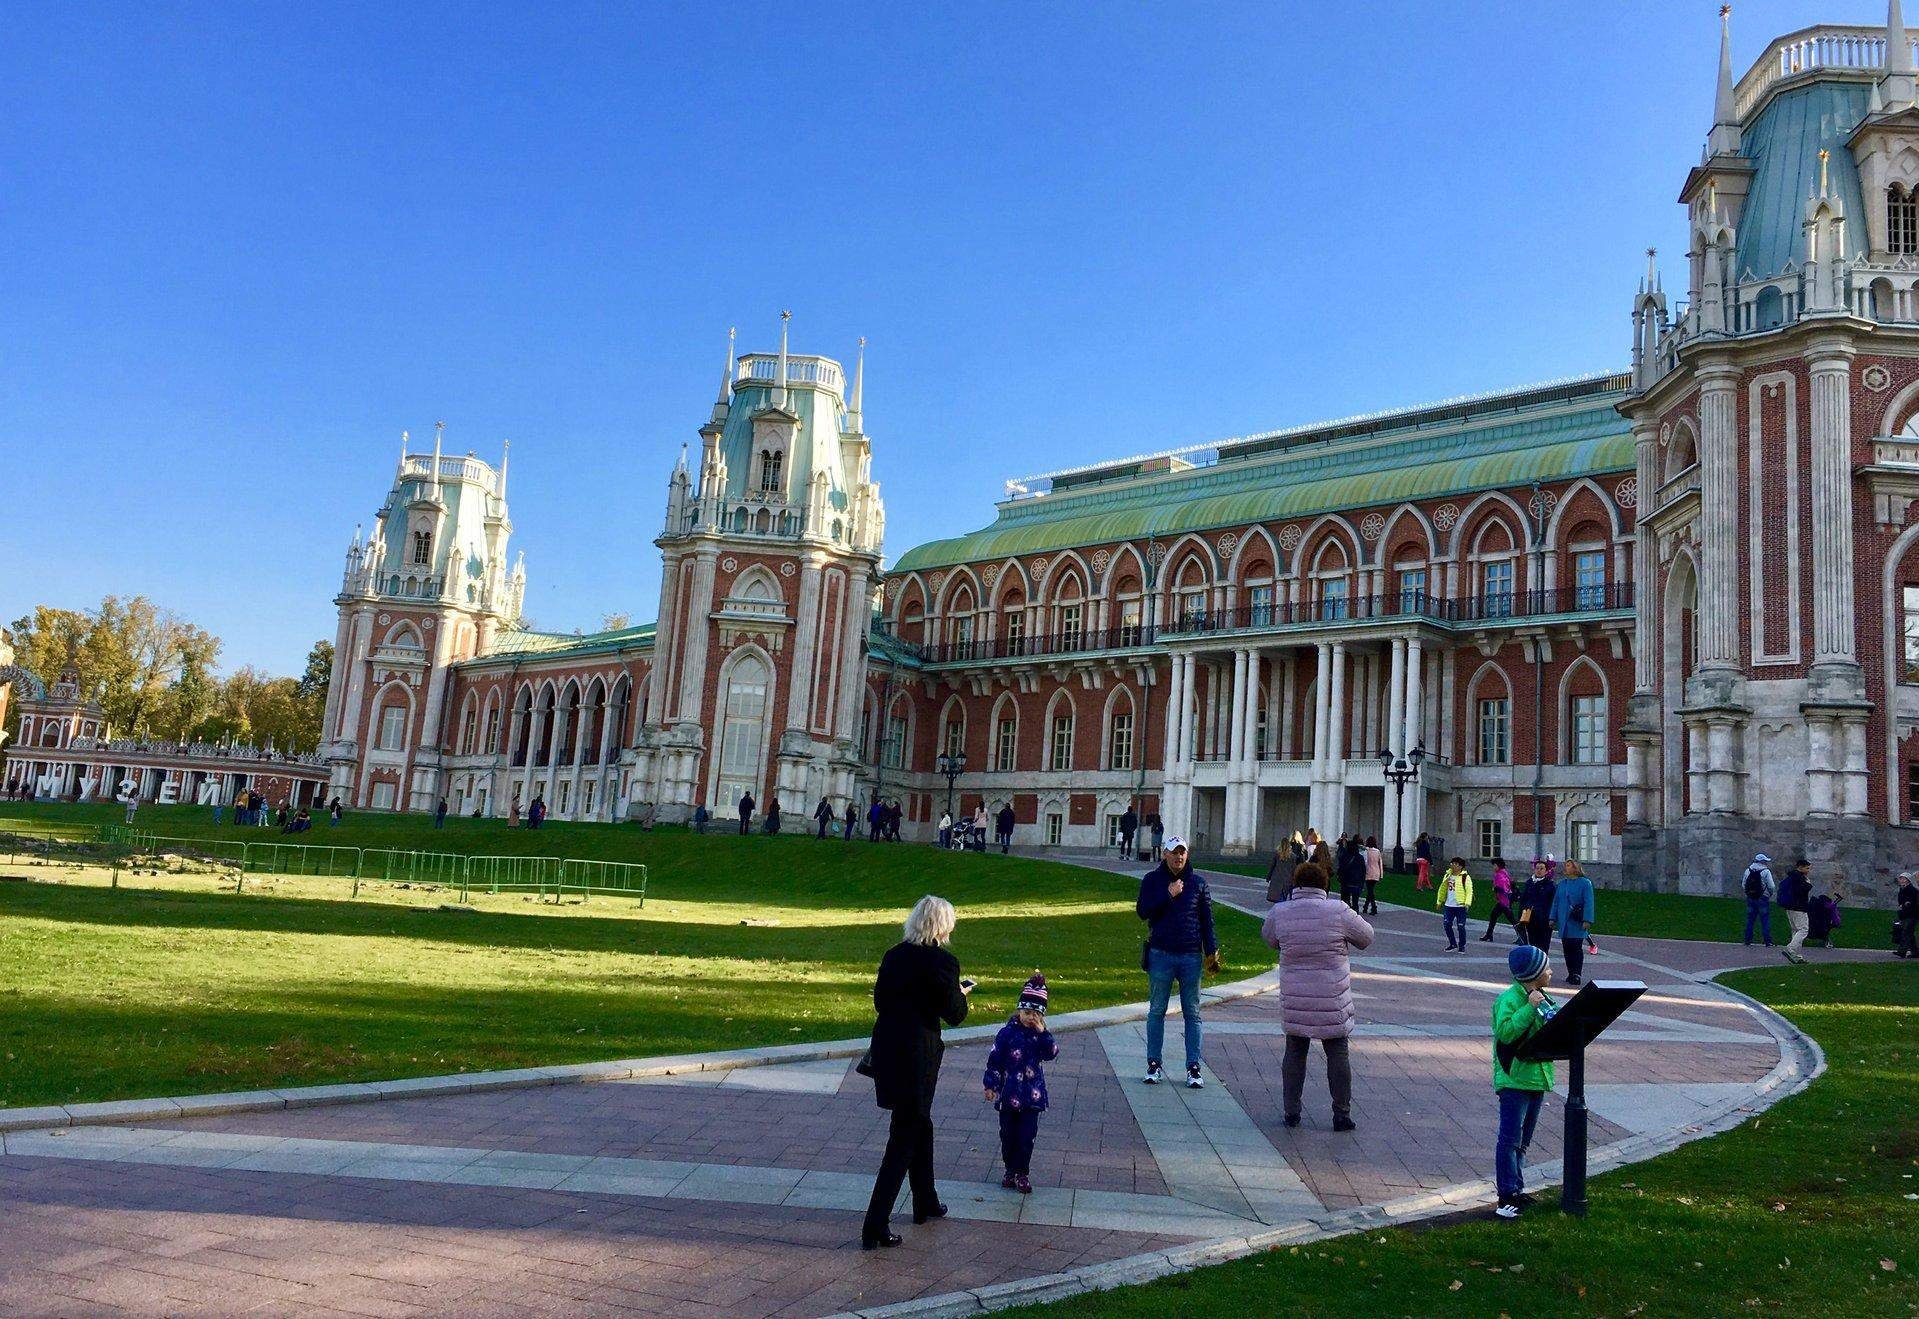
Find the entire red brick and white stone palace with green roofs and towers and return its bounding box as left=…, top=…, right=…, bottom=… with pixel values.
left=303, top=4, right=1919, bottom=891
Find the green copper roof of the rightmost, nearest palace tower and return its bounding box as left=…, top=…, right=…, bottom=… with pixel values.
left=1735, top=81, right=1871, bottom=278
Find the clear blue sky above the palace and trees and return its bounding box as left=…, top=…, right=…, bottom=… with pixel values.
left=0, top=0, right=1849, bottom=670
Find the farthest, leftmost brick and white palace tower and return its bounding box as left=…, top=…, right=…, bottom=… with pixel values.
left=320, top=433, right=522, bottom=810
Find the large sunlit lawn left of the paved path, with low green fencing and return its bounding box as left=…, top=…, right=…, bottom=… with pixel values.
left=0, top=806, right=1267, bottom=1106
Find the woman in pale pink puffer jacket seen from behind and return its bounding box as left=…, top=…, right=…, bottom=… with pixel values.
left=1261, top=862, right=1372, bottom=1131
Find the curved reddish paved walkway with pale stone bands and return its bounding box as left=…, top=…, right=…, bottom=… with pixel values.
left=0, top=875, right=1846, bottom=1315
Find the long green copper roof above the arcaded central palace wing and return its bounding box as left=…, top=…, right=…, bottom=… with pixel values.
left=890, top=382, right=1633, bottom=572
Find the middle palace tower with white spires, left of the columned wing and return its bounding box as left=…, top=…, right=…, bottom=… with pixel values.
left=643, top=313, right=883, bottom=818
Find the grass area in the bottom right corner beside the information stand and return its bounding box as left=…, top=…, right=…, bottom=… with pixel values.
left=1017, top=962, right=1919, bottom=1319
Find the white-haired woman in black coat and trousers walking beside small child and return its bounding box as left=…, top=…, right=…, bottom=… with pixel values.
left=860, top=897, right=973, bottom=1250
